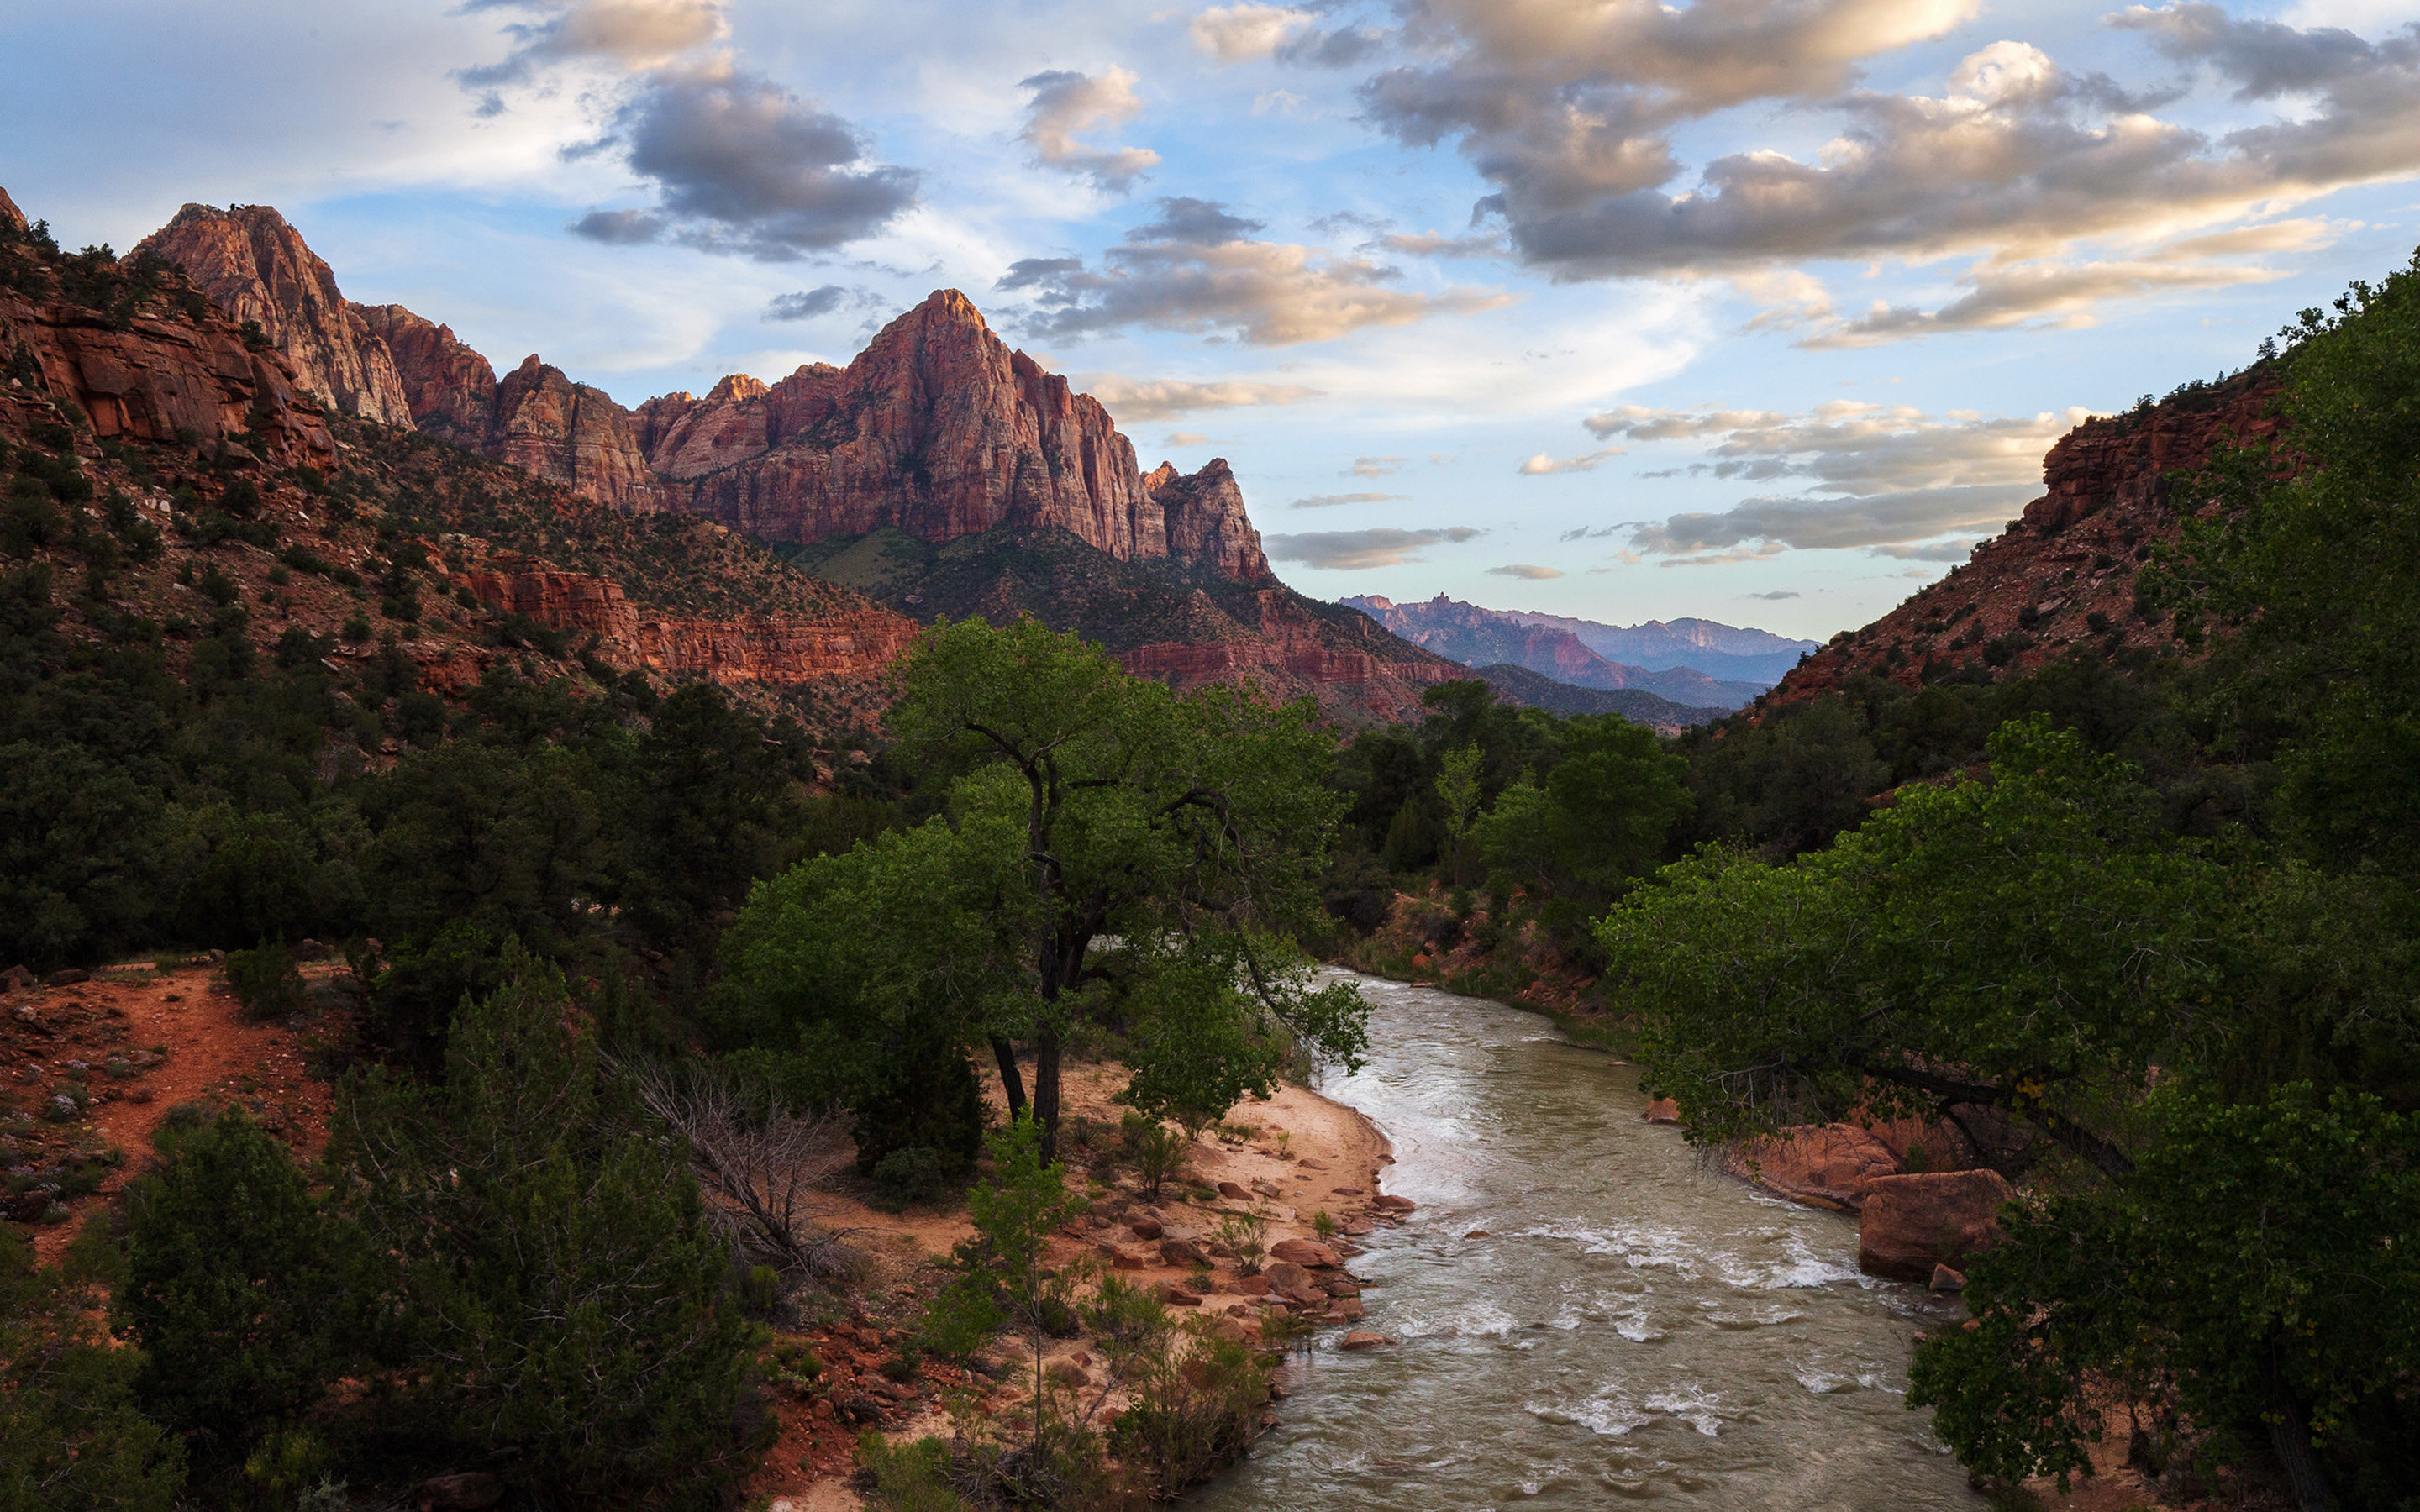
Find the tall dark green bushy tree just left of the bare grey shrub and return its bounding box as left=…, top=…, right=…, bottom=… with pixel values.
left=332, top=951, right=760, bottom=1504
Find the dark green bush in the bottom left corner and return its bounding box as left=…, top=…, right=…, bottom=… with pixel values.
left=0, top=1224, right=184, bottom=1512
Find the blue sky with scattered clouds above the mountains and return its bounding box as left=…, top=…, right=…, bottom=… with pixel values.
left=0, top=0, right=2420, bottom=636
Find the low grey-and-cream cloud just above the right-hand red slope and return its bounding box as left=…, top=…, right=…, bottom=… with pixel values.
left=1585, top=399, right=2084, bottom=564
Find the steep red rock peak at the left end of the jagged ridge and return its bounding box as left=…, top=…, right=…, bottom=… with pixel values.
left=135, top=206, right=412, bottom=426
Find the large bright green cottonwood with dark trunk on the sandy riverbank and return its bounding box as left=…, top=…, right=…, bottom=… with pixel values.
left=718, top=619, right=1367, bottom=1161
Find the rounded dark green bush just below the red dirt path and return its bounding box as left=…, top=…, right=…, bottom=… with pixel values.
left=111, top=1108, right=351, bottom=1473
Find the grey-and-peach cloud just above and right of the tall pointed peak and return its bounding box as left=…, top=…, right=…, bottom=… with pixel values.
left=999, top=196, right=1507, bottom=346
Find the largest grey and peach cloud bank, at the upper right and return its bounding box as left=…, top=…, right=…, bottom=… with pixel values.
left=1362, top=0, right=2420, bottom=312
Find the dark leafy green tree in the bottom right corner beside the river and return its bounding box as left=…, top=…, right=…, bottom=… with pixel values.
left=1909, top=1084, right=2420, bottom=1509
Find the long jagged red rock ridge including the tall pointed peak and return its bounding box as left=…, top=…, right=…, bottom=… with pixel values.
left=143, top=206, right=1268, bottom=583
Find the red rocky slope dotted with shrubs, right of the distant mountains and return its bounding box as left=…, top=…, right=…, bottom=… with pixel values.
left=1771, top=365, right=2282, bottom=699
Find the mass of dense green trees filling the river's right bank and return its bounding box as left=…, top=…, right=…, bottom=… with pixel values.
left=1597, top=264, right=2420, bottom=1512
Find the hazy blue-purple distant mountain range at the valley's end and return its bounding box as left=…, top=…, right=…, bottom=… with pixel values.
left=1341, top=593, right=1818, bottom=709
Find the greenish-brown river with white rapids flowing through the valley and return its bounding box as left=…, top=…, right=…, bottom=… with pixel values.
left=1188, top=973, right=1985, bottom=1512
